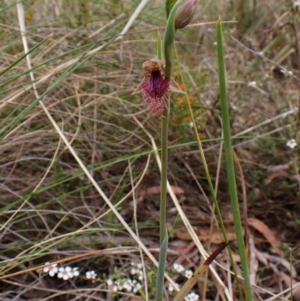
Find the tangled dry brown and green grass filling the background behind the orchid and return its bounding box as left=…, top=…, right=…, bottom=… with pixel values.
left=0, top=0, right=300, bottom=301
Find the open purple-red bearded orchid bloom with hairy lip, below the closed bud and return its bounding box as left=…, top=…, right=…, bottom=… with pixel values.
left=132, top=58, right=185, bottom=116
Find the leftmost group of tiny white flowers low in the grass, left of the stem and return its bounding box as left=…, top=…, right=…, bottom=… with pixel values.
left=43, top=262, right=97, bottom=280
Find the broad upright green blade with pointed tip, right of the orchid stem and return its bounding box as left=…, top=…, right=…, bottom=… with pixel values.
left=217, top=20, right=253, bottom=301
